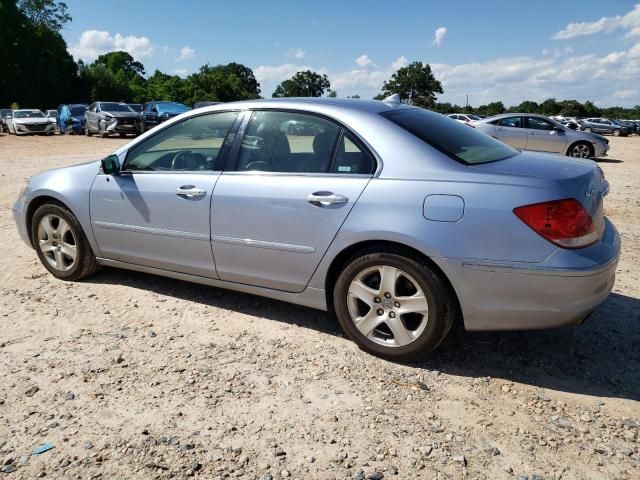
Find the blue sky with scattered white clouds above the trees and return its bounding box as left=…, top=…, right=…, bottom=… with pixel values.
left=62, top=0, right=640, bottom=107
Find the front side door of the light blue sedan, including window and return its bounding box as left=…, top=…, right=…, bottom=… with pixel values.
left=91, top=112, right=238, bottom=278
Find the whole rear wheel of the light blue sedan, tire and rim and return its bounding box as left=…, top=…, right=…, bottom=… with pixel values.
left=333, top=248, right=458, bottom=362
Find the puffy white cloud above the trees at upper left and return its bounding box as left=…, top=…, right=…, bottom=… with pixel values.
left=69, top=30, right=155, bottom=60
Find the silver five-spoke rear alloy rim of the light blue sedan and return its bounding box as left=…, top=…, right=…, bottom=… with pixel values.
left=347, top=265, right=429, bottom=347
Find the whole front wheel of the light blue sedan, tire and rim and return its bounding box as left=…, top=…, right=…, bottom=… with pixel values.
left=31, top=203, right=99, bottom=281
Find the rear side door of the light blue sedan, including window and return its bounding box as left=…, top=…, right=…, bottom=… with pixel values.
left=211, top=110, right=376, bottom=292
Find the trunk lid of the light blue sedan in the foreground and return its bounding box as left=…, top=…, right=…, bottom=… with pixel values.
left=474, top=152, right=609, bottom=214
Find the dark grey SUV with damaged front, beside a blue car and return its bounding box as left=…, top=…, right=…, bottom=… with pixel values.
left=84, top=102, right=138, bottom=138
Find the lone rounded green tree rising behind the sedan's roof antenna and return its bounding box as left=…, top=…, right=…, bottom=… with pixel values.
left=380, top=62, right=444, bottom=107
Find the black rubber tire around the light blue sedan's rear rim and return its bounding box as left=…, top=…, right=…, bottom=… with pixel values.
left=333, top=252, right=446, bottom=361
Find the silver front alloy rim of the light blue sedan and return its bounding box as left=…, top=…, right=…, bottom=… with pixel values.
left=38, top=214, right=78, bottom=272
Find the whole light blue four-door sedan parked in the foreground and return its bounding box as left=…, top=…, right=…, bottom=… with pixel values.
left=13, top=96, right=620, bottom=361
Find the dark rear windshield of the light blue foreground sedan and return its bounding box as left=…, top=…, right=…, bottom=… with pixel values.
left=380, top=108, right=518, bottom=165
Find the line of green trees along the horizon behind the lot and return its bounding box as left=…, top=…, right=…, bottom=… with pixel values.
left=0, top=0, right=640, bottom=119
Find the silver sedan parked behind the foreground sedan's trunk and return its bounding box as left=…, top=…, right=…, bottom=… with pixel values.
left=472, top=113, right=609, bottom=158
